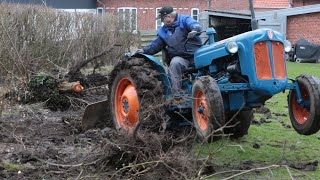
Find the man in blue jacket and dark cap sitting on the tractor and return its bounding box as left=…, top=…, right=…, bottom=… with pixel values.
left=136, top=6, right=202, bottom=94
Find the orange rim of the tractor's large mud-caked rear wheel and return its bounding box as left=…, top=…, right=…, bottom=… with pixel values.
left=114, top=77, right=139, bottom=130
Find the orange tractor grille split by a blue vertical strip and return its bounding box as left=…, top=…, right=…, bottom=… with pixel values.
left=254, top=41, right=286, bottom=80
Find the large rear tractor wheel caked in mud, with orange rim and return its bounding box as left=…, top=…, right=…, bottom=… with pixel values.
left=109, top=58, right=164, bottom=134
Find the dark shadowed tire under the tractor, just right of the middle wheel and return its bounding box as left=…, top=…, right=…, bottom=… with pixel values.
left=225, top=110, right=254, bottom=138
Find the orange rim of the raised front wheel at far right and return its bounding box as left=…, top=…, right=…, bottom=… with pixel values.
left=291, top=87, right=309, bottom=124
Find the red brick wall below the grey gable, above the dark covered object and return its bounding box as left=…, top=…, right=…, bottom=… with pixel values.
left=287, top=12, right=320, bottom=44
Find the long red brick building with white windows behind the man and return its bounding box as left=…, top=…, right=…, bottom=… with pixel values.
left=98, top=0, right=255, bottom=30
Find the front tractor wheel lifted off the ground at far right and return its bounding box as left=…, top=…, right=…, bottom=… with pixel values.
left=288, top=75, right=320, bottom=135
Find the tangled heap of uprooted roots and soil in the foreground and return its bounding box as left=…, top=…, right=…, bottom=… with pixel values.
left=71, top=127, right=214, bottom=179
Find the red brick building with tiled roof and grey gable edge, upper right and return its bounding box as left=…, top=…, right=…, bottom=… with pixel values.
left=254, top=0, right=320, bottom=44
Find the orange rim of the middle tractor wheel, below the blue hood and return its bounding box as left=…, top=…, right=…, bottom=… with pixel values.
left=193, top=91, right=209, bottom=131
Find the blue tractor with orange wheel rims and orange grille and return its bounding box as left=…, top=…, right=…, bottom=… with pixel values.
left=83, top=1, right=320, bottom=140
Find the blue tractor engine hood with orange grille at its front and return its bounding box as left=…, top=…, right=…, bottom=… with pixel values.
left=195, top=29, right=291, bottom=95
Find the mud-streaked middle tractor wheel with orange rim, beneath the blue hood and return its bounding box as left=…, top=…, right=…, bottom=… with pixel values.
left=192, top=76, right=225, bottom=140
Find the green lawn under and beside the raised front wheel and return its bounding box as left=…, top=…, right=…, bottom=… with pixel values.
left=196, top=62, right=320, bottom=179
